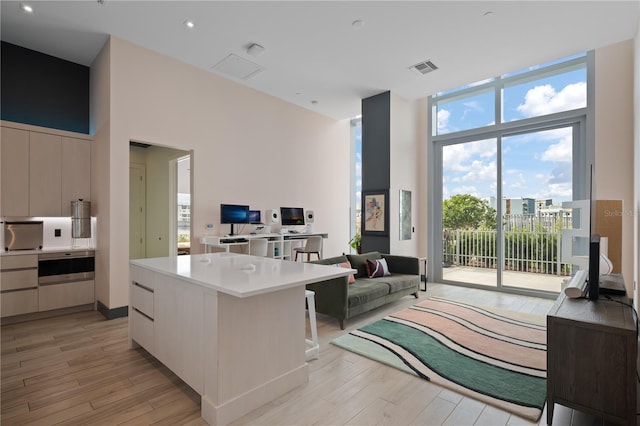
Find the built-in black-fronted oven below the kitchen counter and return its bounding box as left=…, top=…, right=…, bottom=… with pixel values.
left=38, top=250, right=95, bottom=285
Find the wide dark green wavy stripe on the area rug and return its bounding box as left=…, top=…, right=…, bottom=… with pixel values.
left=360, top=320, right=547, bottom=409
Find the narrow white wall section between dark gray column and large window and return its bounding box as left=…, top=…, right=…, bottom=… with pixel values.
left=389, top=93, right=421, bottom=256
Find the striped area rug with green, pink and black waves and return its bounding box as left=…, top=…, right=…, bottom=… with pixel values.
left=331, top=298, right=547, bottom=421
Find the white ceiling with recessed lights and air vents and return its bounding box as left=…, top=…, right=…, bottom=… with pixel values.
left=0, top=0, right=640, bottom=119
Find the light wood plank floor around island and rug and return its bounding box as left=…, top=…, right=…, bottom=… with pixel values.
left=0, top=284, right=632, bottom=426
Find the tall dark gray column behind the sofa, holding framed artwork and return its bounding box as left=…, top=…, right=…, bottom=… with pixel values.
left=362, top=92, right=391, bottom=253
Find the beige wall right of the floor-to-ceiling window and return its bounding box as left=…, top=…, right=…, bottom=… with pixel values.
left=595, top=40, right=637, bottom=294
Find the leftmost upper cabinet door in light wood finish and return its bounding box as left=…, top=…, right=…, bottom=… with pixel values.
left=0, top=127, right=29, bottom=216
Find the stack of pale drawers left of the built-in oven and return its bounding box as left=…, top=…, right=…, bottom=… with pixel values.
left=0, top=254, right=38, bottom=318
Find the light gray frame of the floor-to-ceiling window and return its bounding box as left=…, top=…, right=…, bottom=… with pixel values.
left=427, top=51, right=595, bottom=297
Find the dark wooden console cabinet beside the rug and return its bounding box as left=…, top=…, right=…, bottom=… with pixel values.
left=547, top=288, right=638, bottom=425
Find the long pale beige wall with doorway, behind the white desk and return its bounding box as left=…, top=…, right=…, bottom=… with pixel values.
left=92, top=37, right=350, bottom=308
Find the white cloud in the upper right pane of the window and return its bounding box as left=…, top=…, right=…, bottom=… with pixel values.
left=517, top=82, right=587, bottom=117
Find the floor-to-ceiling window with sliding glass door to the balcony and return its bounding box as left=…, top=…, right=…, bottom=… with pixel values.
left=429, top=54, right=593, bottom=294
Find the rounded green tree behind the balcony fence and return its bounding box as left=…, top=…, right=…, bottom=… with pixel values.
left=442, top=194, right=497, bottom=229
